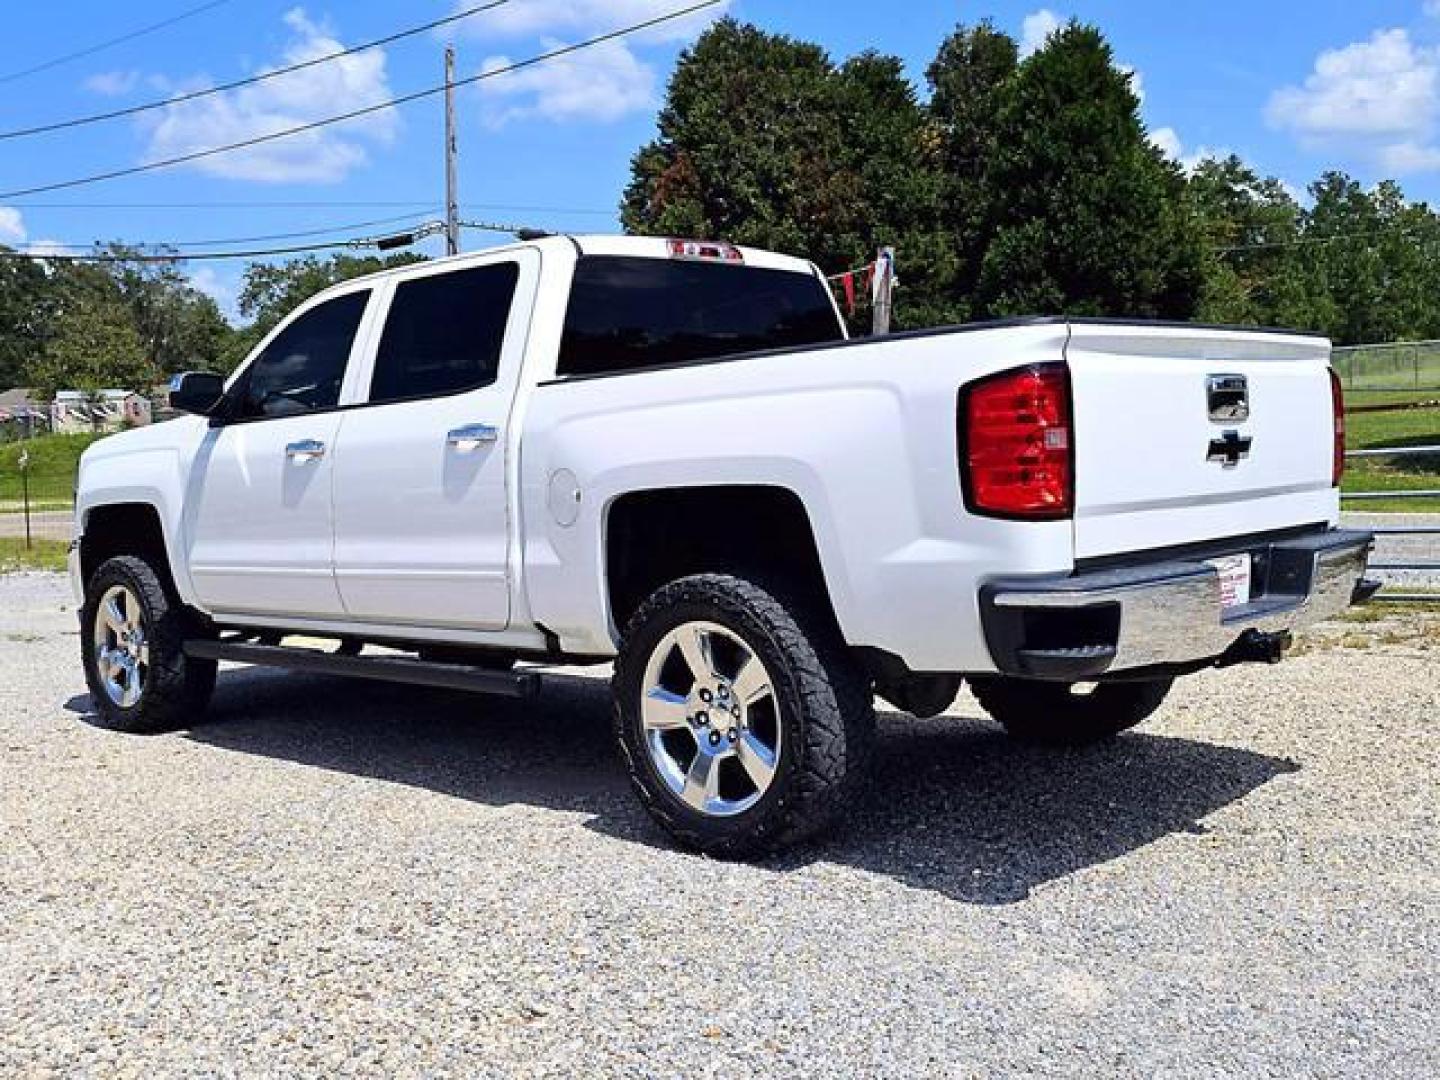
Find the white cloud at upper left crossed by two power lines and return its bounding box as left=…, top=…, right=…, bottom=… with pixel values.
left=141, top=7, right=400, bottom=183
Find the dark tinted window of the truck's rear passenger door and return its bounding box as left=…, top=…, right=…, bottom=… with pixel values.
left=370, top=262, right=520, bottom=403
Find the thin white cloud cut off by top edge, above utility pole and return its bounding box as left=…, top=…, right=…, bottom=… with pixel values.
left=455, top=0, right=730, bottom=42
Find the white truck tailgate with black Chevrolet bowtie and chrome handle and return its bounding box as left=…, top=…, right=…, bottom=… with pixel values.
left=1066, top=323, right=1339, bottom=559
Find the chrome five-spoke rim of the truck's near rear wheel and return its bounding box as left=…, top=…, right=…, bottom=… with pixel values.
left=641, top=622, right=782, bottom=818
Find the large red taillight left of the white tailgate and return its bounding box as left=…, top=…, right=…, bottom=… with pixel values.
left=959, top=364, right=1074, bottom=521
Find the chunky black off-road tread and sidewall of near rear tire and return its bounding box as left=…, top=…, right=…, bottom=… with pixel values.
left=612, top=575, right=876, bottom=858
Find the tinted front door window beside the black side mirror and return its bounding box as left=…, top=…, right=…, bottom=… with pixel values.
left=230, top=291, right=370, bottom=420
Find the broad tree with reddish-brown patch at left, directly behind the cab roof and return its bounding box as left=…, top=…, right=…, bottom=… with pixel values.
left=621, top=19, right=946, bottom=329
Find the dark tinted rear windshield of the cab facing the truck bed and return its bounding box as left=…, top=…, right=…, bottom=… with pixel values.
left=559, top=255, right=844, bottom=374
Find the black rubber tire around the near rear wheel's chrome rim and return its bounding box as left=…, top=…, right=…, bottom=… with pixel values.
left=612, top=575, right=876, bottom=858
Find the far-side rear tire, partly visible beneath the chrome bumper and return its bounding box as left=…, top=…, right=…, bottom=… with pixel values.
left=968, top=677, right=1175, bottom=746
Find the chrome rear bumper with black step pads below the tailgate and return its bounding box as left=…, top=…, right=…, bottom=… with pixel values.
left=981, top=530, right=1375, bottom=681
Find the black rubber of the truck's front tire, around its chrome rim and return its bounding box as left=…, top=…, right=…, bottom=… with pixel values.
left=81, top=556, right=217, bottom=734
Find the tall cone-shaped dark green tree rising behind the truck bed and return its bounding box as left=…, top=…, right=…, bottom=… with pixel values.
left=976, top=23, right=1202, bottom=318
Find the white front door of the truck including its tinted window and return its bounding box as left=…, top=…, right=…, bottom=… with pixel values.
left=186, top=289, right=370, bottom=618
